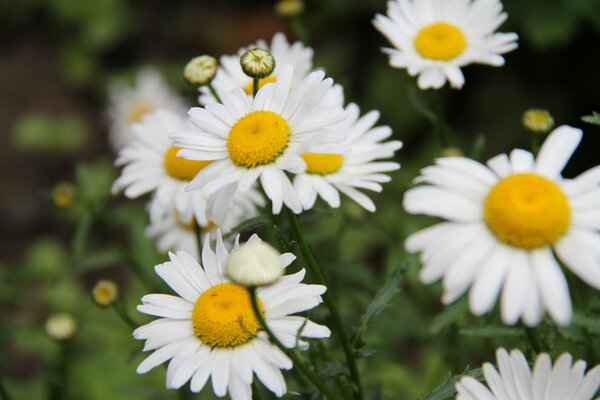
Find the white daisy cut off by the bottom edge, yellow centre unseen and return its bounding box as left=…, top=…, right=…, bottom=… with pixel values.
left=456, top=349, right=600, bottom=400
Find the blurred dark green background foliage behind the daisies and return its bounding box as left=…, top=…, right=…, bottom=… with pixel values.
left=0, top=0, right=600, bottom=400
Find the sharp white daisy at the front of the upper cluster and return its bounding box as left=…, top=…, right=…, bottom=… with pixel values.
left=171, top=65, right=345, bottom=223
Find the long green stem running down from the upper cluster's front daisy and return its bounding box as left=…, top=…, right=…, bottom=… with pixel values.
left=285, top=207, right=363, bottom=399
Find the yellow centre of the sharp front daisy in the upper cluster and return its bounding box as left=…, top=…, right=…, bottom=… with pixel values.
left=227, top=111, right=290, bottom=168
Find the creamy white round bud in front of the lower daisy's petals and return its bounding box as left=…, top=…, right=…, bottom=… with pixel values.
left=225, top=242, right=283, bottom=286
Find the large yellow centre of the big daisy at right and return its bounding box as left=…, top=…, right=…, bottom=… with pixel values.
left=484, top=174, right=571, bottom=249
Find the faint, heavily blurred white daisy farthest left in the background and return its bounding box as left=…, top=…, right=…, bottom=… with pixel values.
left=108, top=68, right=187, bottom=151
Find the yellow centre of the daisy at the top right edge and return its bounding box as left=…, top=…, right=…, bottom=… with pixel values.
left=415, top=22, right=467, bottom=61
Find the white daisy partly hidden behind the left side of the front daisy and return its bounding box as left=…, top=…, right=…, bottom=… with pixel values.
left=113, top=110, right=216, bottom=226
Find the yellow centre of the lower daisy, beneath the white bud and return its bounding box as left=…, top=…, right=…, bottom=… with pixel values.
left=192, top=283, right=264, bottom=347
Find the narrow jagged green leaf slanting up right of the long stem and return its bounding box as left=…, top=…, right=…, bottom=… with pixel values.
left=352, top=261, right=409, bottom=348
